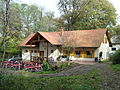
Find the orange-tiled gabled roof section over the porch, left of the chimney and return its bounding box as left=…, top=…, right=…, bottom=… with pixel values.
left=19, top=32, right=61, bottom=47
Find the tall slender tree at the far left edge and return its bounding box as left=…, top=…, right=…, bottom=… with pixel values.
left=0, top=0, right=11, bottom=61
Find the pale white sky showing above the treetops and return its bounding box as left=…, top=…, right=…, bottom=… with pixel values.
left=17, top=0, right=120, bottom=21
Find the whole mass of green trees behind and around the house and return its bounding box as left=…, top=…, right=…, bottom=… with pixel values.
left=0, top=0, right=120, bottom=60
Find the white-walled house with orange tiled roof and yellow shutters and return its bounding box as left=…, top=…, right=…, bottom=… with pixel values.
left=19, top=29, right=112, bottom=61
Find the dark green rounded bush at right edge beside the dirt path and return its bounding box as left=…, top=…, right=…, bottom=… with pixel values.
left=110, top=49, right=120, bottom=64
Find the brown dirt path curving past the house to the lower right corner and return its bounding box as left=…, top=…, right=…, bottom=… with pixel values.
left=0, top=63, right=120, bottom=90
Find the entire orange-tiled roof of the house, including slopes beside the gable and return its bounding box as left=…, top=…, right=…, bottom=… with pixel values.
left=19, top=29, right=107, bottom=47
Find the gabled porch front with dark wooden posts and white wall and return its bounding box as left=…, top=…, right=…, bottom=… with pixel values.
left=22, top=33, right=59, bottom=62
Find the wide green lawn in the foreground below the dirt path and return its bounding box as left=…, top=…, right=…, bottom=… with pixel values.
left=0, top=70, right=101, bottom=90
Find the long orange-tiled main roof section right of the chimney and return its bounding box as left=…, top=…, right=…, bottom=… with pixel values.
left=62, top=29, right=106, bottom=47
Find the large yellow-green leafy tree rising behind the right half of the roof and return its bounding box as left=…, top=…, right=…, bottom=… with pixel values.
left=57, top=0, right=116, bottom=30
